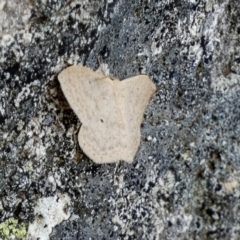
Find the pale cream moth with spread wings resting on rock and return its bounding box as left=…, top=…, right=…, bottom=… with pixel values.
left=58, top=66, right=156, bottom=163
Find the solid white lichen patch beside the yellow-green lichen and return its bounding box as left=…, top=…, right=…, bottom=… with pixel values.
left=27, top=194, right=70, bottom=240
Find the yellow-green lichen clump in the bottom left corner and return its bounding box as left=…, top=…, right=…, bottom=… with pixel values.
left=0, top=217, right=27, bottom=240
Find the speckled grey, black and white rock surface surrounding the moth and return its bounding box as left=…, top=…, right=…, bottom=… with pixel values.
left=0, top=0, right=240, bottom=240
